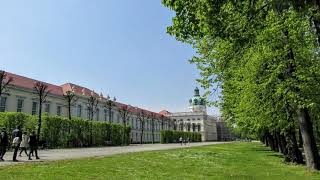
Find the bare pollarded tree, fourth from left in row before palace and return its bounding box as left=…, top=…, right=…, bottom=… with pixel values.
left=86, top=91, right=99, bottom=146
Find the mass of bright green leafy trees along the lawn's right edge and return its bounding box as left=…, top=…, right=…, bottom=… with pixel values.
left=162, top=0, right=320, bottom=169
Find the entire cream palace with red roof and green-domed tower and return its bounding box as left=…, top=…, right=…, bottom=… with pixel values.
left=0, top=72, right=225, bottom=143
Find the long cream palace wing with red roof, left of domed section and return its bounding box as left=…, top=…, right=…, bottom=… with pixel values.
left=0, top=73, right=173, bottom=143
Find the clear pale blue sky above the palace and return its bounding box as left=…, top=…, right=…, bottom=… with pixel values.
left=0, top=0, right=220, bottom=113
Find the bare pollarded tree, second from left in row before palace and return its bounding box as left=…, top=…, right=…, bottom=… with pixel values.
left=33, top=81, right=50, bottom=141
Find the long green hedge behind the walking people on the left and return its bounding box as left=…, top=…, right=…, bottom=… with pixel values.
left=0, top=112, right=131, bottom=148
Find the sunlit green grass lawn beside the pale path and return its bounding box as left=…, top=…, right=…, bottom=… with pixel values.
left=0, top=143, right=320, bottom=180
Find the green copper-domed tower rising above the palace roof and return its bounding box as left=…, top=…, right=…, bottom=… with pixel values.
left=189, top=87, right=207, bottom=113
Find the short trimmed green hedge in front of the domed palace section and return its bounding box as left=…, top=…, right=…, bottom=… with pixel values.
left=161, top=130, right=201, bottom=144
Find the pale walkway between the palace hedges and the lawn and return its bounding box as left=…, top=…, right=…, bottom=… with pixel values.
left=0, top=142, right=225, bottom=166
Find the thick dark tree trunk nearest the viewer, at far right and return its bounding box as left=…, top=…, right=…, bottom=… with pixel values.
left=297, top=108, right=320, bottom=170
